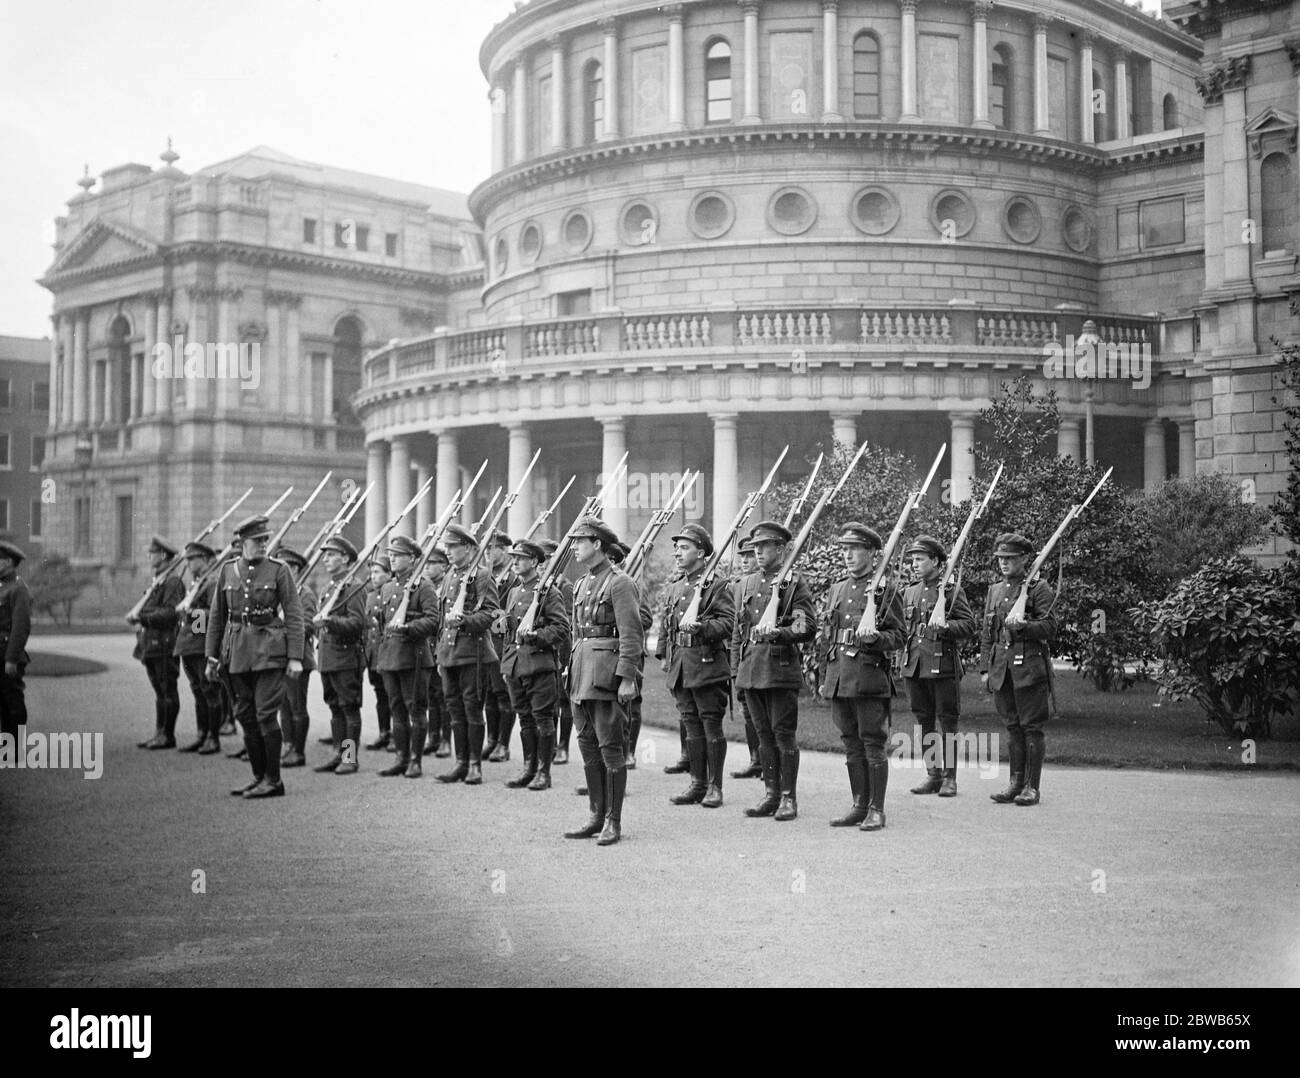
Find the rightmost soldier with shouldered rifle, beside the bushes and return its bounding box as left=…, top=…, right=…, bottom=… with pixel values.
left=979, top=532, right=1058, bottom=805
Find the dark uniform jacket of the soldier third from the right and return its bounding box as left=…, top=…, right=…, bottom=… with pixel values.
left=818, top=573, right=906, bottom=700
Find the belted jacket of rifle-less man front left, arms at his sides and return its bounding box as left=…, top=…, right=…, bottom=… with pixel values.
left=205, top=558, right=303, bottom=674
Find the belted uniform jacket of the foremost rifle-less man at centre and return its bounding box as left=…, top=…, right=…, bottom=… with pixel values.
left=569, top=562, right=645, bottom=700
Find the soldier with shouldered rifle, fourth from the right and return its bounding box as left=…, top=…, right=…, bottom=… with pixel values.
left=732, top=520, right=815, bottom=821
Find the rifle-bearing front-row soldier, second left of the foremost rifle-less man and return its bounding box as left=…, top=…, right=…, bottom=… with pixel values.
left=438, top=524, right=501, bottom=785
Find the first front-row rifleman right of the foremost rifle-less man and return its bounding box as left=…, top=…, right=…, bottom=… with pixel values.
left=659, top=524, right=736, bottom=809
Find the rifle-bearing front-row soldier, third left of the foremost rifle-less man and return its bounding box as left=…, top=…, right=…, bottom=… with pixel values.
left=378, top=536, right=438, bottom=779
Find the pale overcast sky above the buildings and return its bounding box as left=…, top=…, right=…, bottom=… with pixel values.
left=0, top=0, right=1158, bottom=337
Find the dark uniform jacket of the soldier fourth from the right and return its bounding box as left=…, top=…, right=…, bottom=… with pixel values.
left=731, top=570, right=815, bottom=689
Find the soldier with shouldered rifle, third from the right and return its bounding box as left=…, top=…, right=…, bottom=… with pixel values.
left=819, top=520, right=906, bottom=831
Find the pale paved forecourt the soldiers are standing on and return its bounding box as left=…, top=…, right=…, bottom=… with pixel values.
left=0, top=636, right=1300, bottom=986
